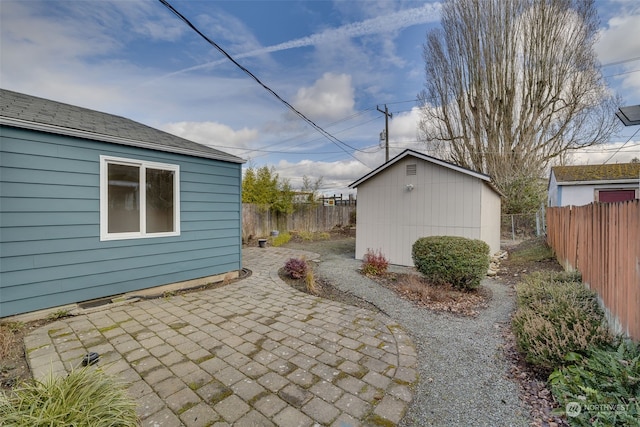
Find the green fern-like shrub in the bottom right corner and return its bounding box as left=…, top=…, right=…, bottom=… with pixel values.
left=549, top=341, right=640, bottom=426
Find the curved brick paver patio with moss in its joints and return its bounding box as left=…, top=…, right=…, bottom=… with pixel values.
left=25, top=248, right=418, bottom=427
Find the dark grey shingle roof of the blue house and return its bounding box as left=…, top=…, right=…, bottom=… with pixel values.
left=0, top=89, right=244, bottom=163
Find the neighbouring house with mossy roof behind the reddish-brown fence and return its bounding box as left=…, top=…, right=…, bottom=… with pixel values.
left=548, top=163, right=640, bottom=206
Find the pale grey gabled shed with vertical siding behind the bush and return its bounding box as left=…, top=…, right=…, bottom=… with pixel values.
left=350, top=150, right=501, bottom=266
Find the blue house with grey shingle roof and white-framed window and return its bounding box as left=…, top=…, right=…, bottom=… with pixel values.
left=0, top=90, right=243, bottom=317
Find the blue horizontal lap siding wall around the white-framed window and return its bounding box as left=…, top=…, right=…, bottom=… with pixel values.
left=0, top=127, right=241, bottom=316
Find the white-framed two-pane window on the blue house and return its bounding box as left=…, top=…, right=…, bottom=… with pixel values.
left=100, top=156, right=180, bottom=240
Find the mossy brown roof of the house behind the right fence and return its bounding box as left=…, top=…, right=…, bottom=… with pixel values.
left=551, top=163, right=640, bottom=182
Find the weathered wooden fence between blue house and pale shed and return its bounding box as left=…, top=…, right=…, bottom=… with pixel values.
left=242, top=203, right=356, bottom=241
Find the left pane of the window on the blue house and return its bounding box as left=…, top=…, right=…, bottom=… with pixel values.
left=107, top=164, right=140, bottom=233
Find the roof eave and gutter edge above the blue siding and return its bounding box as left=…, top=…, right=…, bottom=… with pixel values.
left=0, top=116, right=246, bottom=163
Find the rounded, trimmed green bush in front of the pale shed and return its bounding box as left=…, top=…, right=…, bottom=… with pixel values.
left=411, top=236, right=489, bottom=290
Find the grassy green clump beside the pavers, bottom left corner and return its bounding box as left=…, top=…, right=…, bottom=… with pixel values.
left=0, top=367, right=138, bottom=427
